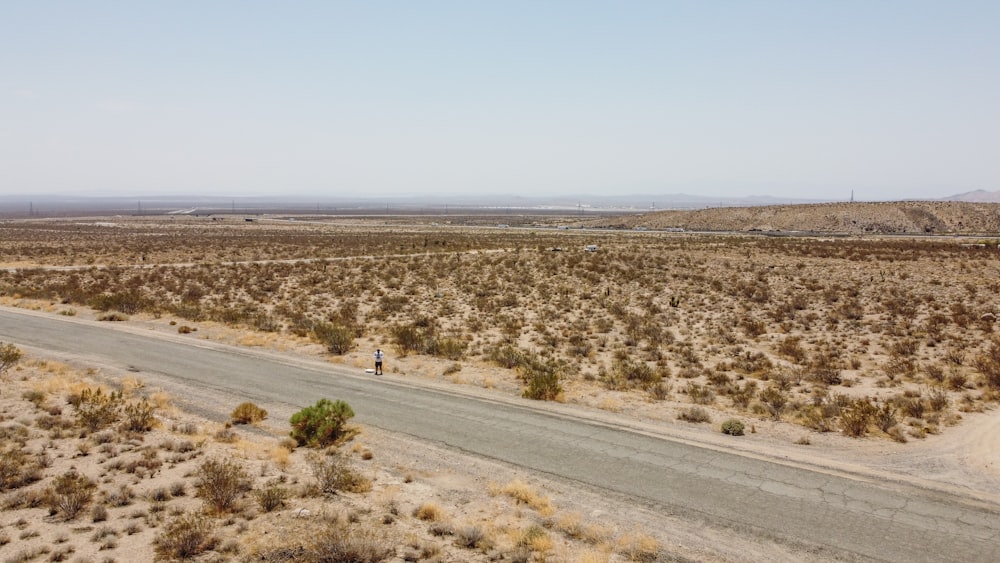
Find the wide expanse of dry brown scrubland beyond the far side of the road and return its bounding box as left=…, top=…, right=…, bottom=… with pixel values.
left=0, top=214, right=1000, bottom=441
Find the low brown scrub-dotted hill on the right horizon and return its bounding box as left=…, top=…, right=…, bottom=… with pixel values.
left=587, top=201, right=1000, bottom=234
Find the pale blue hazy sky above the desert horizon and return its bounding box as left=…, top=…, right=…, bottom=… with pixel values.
left=0, top=0, right=1000, bottom=200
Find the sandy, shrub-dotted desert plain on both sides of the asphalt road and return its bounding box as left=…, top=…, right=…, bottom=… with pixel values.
left=0, top=205, right=1000, bottom=561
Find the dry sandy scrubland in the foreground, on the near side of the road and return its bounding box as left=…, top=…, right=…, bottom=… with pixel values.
left=0, top=352, right=659, bottom=563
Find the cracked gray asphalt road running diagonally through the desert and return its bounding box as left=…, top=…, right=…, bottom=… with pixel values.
left=0, top=308, right=1000, bottom=561
